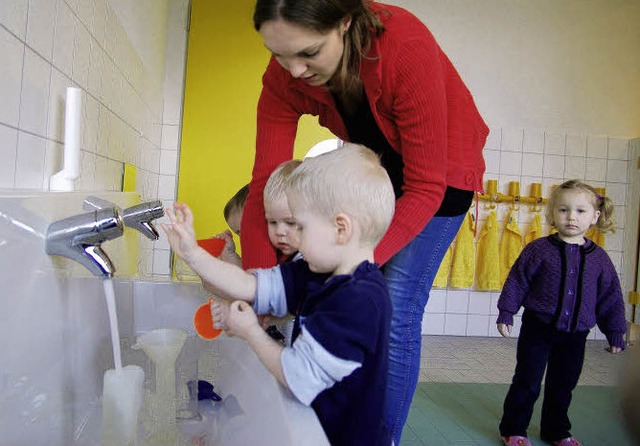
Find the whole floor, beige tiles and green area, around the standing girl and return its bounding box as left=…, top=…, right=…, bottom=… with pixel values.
left=401, top=336, right=640, bottom=446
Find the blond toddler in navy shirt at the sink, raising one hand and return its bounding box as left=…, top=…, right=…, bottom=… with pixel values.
left=162, top=144, right=395, bottom=446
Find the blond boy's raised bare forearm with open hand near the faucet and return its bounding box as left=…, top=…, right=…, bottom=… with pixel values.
left=161, top=203, right=256, bottom=302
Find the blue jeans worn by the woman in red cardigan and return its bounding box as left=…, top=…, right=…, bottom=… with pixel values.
left=384, top=214, right=465, bottom=446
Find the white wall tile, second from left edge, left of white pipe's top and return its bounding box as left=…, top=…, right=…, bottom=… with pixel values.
left=19, top=48, right=51, bottom=136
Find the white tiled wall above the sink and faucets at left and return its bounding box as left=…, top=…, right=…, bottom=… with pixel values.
left=0, top=0, right=188, bottom=275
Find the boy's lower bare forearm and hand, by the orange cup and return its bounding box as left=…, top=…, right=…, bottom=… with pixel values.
left=222, top=300, right=288, bottom=387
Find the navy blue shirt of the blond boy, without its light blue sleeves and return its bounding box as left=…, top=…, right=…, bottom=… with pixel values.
left=279, top=260, right=391, bottom=446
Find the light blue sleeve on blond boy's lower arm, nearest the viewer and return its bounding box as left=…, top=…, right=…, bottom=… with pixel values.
left=280, top=327, right=362, bottom=406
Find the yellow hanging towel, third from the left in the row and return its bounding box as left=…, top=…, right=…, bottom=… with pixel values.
left=476, top=211, right=500, bottom=291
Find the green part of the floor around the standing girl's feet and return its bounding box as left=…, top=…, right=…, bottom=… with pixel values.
left=401, top=383, right=632, bottom=446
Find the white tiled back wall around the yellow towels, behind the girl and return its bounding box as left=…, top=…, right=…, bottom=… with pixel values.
left=423, top=127, right=638, bottom=338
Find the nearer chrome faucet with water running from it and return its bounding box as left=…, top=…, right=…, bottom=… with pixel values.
left=45, top=207, right=124, bottom=278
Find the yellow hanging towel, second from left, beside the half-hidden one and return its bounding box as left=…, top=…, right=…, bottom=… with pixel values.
left=449, top=212, right=476, bottom=288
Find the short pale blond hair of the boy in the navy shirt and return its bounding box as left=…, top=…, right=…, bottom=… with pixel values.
left=287, top=143, right=395, bottom=247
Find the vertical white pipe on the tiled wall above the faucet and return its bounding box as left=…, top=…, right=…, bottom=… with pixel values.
left=49, top=87, right=82, bottom=191
